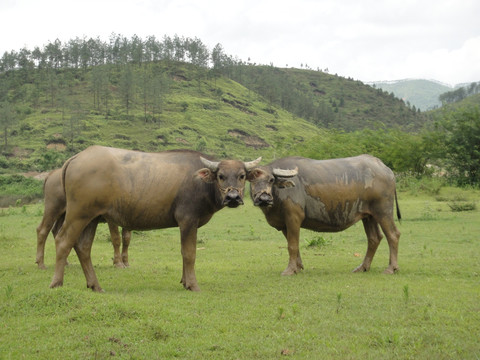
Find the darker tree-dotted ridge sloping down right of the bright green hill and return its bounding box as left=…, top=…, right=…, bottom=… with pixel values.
left=223, top=66, right=426, bottom=132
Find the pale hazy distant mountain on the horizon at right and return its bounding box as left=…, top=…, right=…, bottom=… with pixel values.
left=369, top=79, right=454, bottom=111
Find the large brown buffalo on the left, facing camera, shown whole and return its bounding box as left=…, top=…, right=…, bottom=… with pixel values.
left=50, top=146, right=261, bottom=291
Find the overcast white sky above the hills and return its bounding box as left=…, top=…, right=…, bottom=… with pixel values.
left=0, top=0, right=480, bottom=85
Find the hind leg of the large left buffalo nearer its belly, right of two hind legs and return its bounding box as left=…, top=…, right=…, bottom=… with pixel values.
left=74, top=218, right=103, bottom=292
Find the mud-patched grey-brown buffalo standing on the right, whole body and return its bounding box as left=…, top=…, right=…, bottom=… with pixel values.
left=248, top=155, right=401, bottom=275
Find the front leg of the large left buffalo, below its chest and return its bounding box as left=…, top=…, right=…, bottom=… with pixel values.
left=180, top=224, right=200, bottom=291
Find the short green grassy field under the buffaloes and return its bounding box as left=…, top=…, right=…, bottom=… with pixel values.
left=0, top=188, right=480, bottom=359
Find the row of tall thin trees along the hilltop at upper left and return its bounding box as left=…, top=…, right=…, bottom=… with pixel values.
left=0, top=34, right=211, bottom=72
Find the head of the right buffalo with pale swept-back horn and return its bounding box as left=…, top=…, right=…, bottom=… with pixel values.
left=247, top=166, right=298, bottom=206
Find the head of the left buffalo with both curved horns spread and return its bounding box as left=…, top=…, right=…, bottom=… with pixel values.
left=197, top=157, right=262, bottom=208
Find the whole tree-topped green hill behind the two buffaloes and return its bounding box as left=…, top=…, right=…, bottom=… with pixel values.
left=0, top=36, right=425, bottom=172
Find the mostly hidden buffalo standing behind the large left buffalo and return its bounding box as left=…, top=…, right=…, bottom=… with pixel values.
left=36, top=169, right=131, bottom=269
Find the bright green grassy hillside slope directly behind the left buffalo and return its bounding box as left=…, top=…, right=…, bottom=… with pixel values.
left=0, top=63, right=325, bottom=172
